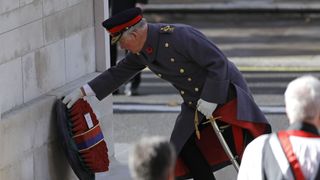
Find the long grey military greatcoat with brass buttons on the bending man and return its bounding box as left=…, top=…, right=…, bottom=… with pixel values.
left=89, top=24, right=267, bottom=152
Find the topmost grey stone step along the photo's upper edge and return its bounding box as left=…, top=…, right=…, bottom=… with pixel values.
left=144, top=1, right=320, bottom=13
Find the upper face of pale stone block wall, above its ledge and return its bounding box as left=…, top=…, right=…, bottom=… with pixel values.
left=0, top=0, right=95, bottom=112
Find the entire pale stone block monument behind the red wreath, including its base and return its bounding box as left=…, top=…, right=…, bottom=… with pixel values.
left=0, top=0, right=114, bottom=180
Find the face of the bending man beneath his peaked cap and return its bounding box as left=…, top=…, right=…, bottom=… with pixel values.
left=119, top=33, right=141, bottom=53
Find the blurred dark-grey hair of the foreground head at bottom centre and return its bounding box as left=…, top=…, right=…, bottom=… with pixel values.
left=129, top=136, right=176, bottom=180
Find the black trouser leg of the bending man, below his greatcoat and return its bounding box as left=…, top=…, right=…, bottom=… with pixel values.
left=180, top=134, right=215, bottom=180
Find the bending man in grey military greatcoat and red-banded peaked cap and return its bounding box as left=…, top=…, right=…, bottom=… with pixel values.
left=63, top=8, right=270, bottom=180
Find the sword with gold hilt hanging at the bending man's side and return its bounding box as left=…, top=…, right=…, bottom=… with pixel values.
left=194, top=109, right=239, bottom=172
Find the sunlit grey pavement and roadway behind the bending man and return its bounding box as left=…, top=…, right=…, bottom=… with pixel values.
left=97, top=8, right=320, bottom=180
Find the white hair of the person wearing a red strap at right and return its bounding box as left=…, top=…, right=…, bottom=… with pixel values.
left=284, top=75, right=320, bottom=123
